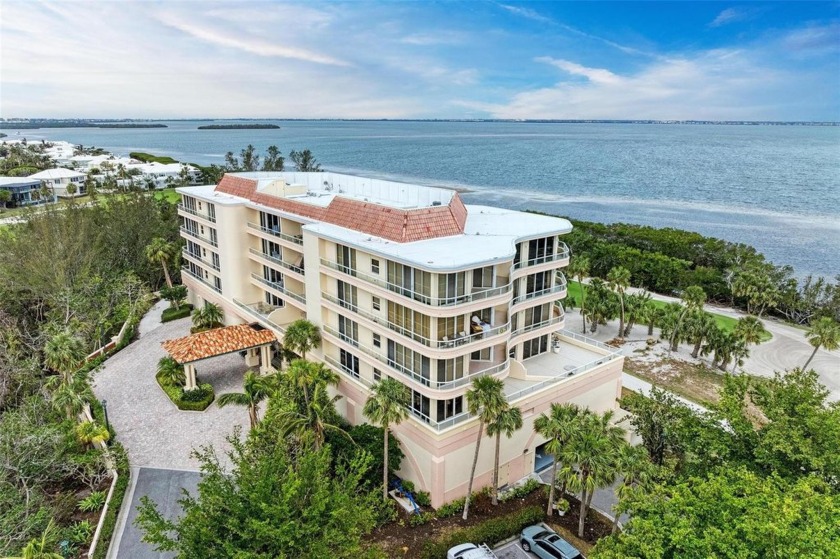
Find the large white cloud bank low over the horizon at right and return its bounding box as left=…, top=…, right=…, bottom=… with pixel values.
left=460, top=50, right=800, bottom=120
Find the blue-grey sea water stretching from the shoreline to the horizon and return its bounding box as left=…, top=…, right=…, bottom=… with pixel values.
left=3, top=119, right=840, bottom=277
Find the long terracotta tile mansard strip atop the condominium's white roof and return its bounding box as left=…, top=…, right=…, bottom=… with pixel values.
left=216, top=175, right=467, bottom=243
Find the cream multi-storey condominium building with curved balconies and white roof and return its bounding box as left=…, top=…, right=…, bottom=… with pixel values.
left=178, top=173, right=623, bottom=507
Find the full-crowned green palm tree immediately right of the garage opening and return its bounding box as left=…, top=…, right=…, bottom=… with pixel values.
left=563, top=410, right=624, bottom=538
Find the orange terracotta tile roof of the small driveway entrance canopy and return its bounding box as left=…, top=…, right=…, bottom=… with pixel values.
left=161, top=324, right=277, bottom=364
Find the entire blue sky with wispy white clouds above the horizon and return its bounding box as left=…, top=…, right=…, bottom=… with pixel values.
left=0, top=0, right=840, bottom=121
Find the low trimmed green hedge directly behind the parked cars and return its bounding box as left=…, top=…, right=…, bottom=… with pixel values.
left=420, top=506, right=545, bottom=559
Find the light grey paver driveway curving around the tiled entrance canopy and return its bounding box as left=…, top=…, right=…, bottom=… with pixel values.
left=93, top=302, right=248, bottom=470
